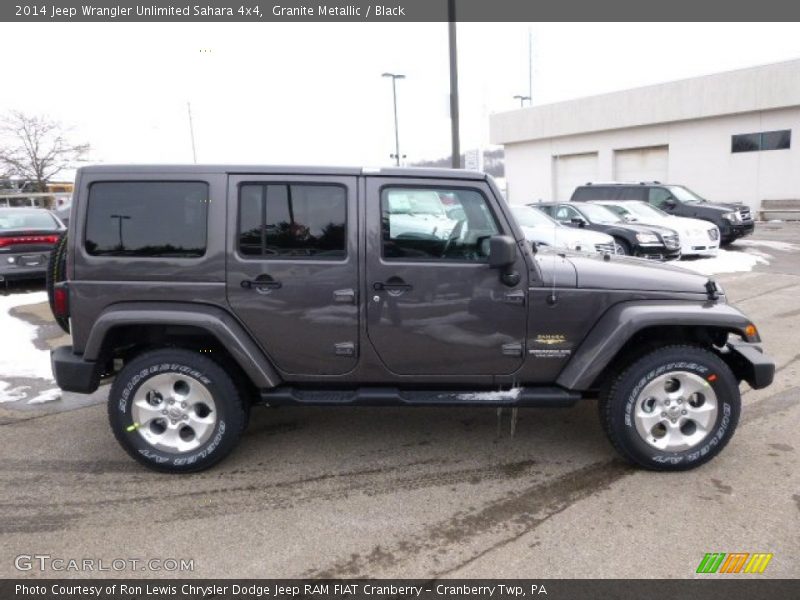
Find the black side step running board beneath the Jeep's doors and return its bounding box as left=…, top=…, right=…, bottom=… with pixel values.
left=261, top=387, right=581, bottom=407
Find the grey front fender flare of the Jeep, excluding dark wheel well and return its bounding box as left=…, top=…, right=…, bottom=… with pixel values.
left=557, top=301, right=759, bottom=391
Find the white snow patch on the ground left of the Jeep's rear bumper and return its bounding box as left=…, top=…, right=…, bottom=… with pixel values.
left=0, top=292, right=53, bottom=382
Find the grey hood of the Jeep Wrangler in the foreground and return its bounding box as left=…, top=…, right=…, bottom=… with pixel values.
left=567, top=255, right=708, bottom=294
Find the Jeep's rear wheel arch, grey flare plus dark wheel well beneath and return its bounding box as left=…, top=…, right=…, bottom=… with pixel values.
left=83, top=302, right=281, bottom=388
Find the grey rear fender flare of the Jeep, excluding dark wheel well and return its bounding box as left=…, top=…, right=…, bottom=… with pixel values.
left=83, top=302, right=281, bottom=388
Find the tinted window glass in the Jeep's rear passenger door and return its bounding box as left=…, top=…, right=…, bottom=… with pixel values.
left=239, top=183, right=347, bottom=259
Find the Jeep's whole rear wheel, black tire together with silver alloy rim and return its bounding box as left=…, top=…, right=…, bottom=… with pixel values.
left=108, top=349, right=247, bottom=473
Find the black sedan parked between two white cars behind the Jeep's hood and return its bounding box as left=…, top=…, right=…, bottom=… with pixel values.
left=530, top=202, right=681, bottom=260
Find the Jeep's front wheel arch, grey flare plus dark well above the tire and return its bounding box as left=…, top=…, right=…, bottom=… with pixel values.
left=557, top=301, right=760, bottom=391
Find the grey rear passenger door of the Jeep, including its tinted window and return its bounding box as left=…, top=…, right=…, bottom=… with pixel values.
left=227, top=175, right=358, bottom=375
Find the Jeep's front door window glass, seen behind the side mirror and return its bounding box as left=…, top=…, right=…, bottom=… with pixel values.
left=381, top=187, right=499, bottom=262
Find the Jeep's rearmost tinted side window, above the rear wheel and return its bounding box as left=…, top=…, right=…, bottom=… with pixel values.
left=86, top=181, right=208, bottom=258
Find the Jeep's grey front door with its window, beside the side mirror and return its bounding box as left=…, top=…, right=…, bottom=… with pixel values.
left=363, top=177, right=528, bottom=376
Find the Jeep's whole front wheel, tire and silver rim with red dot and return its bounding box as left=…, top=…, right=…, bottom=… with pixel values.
left=599, top=346, right=741, bottom=471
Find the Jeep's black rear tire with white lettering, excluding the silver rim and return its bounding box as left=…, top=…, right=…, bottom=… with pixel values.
left=108, top=348, right=249, bottom=473
